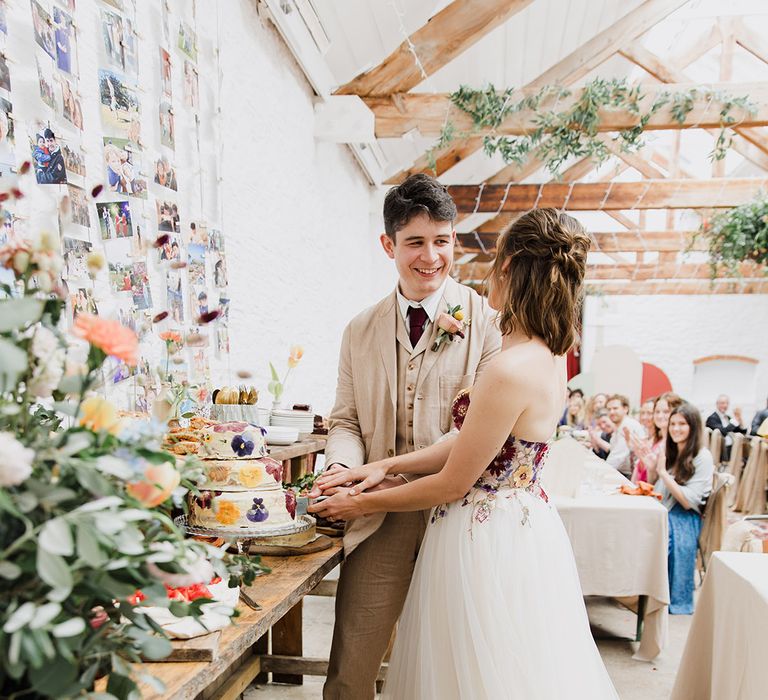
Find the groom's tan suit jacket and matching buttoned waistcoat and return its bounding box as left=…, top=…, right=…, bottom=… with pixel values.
left=325, top=278, right=501, bottom=555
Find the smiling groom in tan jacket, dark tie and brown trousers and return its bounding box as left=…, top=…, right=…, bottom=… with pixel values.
left=313, top=174, right=501, bottom=700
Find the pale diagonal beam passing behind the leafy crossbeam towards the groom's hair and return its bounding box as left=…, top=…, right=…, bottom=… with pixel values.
left=387, top=0, right=688, bottom=184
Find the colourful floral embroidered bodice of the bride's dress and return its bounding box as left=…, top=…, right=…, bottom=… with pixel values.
left=432, top=389, right=549, bottom=524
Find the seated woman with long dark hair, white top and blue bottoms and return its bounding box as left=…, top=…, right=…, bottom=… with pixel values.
left=648, top=403, right=715, bottom=615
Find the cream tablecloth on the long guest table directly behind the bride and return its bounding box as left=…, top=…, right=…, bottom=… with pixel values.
left=544, top=440, right=669, bottom=661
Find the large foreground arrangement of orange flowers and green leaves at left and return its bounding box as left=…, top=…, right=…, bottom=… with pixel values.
left=0, top=201, right=263, bottom=698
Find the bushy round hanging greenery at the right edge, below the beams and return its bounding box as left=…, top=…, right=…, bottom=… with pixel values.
left=696, top=192, right=768, bottom=277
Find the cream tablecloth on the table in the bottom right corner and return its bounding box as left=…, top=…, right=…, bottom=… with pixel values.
left=672, top=552, right=768, bottom=700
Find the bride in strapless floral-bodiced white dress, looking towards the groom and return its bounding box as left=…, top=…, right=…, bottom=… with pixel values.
left=310, top=209, right=618, bottom=700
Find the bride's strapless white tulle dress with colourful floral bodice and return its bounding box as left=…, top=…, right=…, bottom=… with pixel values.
left=383, top=392, right=618, bottom=700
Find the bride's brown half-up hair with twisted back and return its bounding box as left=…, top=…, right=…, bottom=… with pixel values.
left=489, top=208, right=590, bottom=355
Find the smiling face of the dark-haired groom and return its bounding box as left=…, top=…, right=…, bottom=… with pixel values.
left=381, top=214, right=456, bottom=301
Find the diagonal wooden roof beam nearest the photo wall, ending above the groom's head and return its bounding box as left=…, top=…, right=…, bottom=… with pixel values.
left=335, top=0, right=532, bottom=95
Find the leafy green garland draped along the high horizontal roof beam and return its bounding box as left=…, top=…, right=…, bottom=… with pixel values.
left=428, top=78, right=757, bottom=175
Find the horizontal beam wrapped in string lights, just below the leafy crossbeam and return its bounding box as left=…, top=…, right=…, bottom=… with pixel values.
left=448, top=178, right=768, bottom=213
